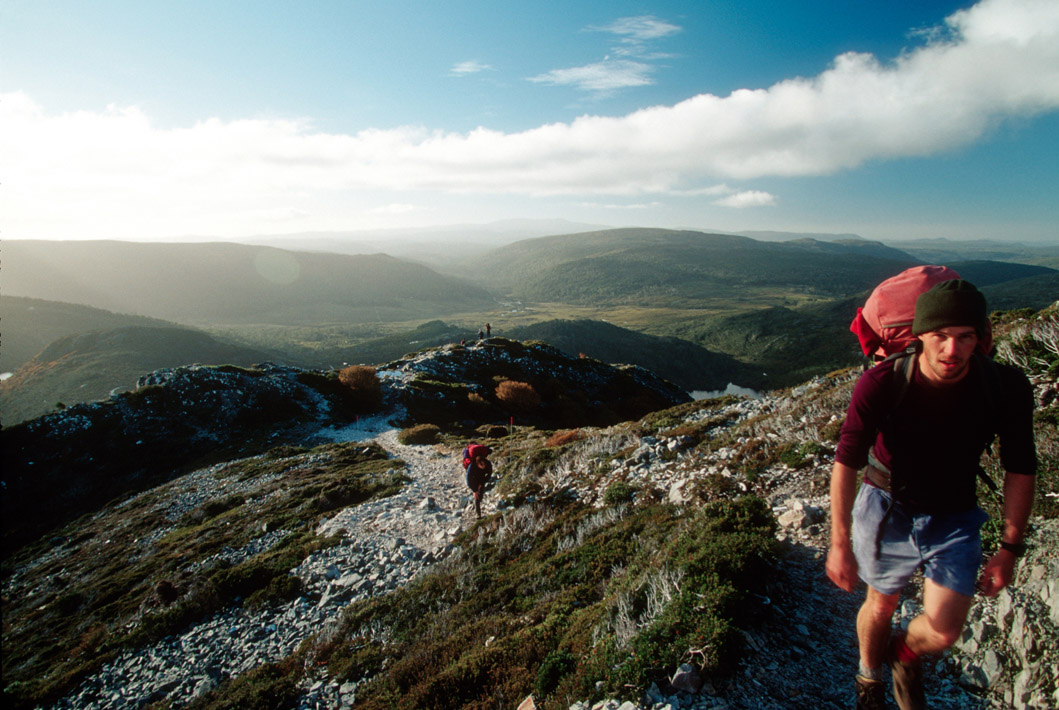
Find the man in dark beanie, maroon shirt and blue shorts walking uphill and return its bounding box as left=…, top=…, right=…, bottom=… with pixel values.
left=827, top=279, right=1037, bottom=710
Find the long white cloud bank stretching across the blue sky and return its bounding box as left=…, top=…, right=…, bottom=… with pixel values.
left=0, top=0, right=1059, bottom=235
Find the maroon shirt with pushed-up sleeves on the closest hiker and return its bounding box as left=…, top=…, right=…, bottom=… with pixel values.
left=834, top=357, right=1037, bottom=512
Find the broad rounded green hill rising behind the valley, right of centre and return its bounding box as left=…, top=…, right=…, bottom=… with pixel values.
left=474, top=229, right=916, bottom=307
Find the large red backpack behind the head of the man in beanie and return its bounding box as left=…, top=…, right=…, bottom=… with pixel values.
left=849, top=265, right=992, bottom=360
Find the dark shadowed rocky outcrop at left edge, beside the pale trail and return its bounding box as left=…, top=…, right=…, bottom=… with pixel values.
left=0, top=365, right=353, bottom=550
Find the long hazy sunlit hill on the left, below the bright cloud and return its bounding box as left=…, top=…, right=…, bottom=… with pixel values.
left=4, top=241, right=492, bottom=324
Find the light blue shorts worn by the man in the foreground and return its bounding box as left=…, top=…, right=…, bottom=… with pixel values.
left=854, top=483, right=989, bottom=597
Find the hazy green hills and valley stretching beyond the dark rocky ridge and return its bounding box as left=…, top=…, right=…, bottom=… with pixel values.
left=0, top=231, right=1059, bottom=424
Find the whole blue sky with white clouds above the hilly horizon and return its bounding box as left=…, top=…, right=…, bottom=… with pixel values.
left=0, top=0, right=1059, bottom=243
